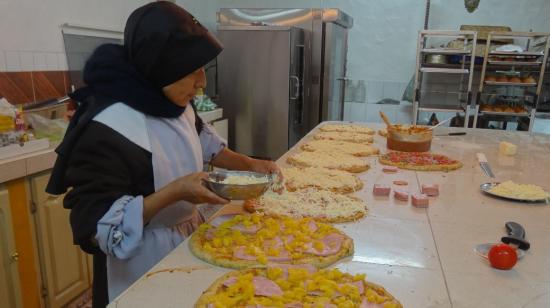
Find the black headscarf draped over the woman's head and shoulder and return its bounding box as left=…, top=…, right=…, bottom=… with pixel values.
left=46, top=1, right=222, bottom=194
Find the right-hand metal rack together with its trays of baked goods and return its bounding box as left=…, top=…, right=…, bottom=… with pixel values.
left=474, top=32, right=550, bottom=131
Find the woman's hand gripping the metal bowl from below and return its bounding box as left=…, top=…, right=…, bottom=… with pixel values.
left=174, top=172, right=229, bottom=204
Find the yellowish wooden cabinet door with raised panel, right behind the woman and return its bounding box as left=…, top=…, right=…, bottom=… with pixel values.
left=31, top=173, right=90, bottom=308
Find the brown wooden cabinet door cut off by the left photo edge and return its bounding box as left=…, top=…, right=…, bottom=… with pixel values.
left=0, top=186, right=22, bottom=308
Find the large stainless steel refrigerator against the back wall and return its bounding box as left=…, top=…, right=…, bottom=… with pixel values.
left=217, top=9, right=353, bottom=159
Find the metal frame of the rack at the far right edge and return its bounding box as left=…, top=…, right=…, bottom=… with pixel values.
left=474, top=32, right=550, bottom=131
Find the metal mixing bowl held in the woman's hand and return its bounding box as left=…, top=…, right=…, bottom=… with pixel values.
left=205, top=170, right=274, bottom=200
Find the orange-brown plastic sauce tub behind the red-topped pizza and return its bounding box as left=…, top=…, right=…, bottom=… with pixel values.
left=386, top=124, right=433, bottom=152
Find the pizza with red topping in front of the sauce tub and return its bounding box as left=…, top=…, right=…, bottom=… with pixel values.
left=379, top=152, right=462, bottom=171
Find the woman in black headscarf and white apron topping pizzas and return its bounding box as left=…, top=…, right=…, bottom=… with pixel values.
left=47, top=1, right=280, bottom=307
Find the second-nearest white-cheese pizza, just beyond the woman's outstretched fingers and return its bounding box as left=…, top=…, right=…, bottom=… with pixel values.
left=282, top=167, right=363, bottom=194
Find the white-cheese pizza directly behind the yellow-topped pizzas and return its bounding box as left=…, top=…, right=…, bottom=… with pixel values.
left=244, top=189, right=368, bottom=223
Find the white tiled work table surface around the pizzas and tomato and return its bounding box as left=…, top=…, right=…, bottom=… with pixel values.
left=105, top=124, right=550, bottom=308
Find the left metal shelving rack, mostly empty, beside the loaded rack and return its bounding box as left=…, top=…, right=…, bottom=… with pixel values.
left=413, top=30, right=477, bottom=127
